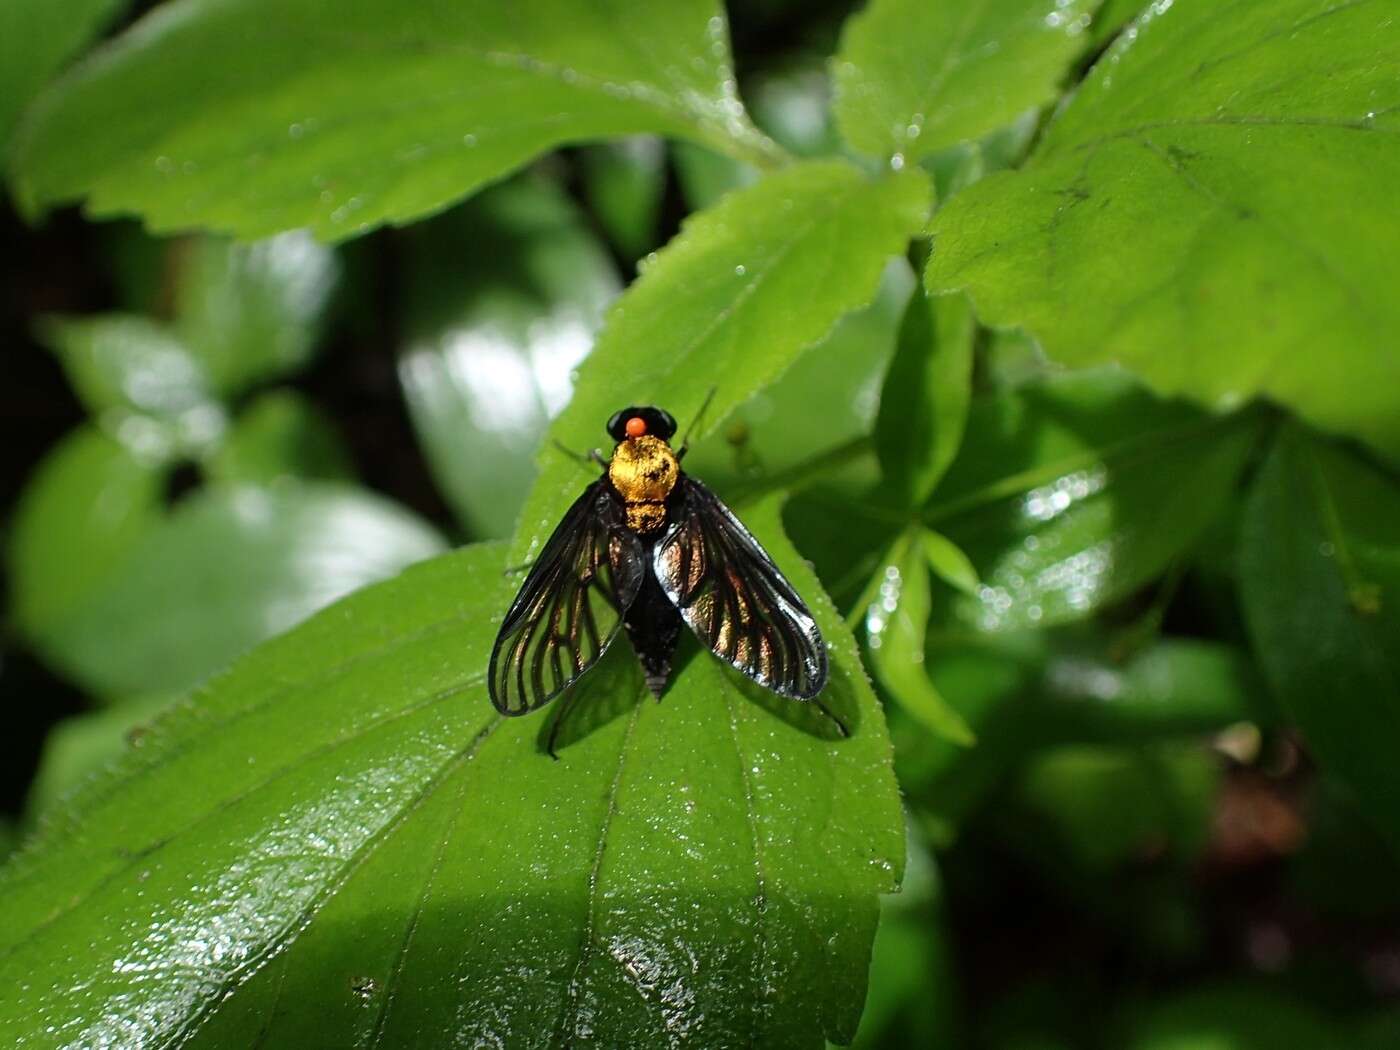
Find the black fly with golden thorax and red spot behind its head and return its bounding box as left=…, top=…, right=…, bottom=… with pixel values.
left=490, top=406, right=828, bottom=755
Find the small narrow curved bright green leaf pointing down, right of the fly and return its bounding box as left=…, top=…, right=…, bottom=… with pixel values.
left=865, top=526, right=974, bottom=746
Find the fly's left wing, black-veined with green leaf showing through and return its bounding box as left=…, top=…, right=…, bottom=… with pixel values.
left=489, top=480, right=645, bottom=714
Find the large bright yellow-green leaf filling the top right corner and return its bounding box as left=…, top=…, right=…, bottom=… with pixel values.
left=927, top=0, right=1400, bottom=455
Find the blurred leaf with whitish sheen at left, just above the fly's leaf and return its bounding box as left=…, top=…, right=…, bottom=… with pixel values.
left=43, top=483, right=442, bottom=696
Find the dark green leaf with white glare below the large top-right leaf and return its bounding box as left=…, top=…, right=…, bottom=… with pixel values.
left=924, top=372, right=1260, bottom=631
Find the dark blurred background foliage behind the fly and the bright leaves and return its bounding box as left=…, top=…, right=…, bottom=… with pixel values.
left=0, top=0, right=1400, bottom=1050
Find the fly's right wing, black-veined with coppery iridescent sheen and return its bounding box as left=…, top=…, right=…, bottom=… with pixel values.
left=652, top=475, right=826, bottom=700
